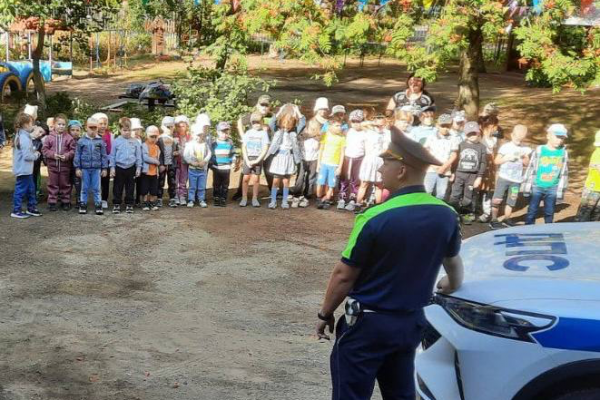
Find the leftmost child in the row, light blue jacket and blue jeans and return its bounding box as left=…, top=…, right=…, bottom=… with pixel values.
left=10, top=113, right=42, bottom=219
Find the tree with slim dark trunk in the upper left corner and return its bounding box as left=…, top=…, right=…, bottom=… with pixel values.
left=0, top=0, right=118, bottom=109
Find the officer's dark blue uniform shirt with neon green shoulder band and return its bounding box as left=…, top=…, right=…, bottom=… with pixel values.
left=342, top=186, right=461, bottom=312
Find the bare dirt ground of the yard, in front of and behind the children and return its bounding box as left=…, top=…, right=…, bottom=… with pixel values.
left=0, top=60, right=600, bottom=400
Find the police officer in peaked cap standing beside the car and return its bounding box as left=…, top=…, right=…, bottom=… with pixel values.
left=316, top=127, right=463, bottom=400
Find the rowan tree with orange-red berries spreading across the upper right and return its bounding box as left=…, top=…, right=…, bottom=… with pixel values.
left=243, top=0, right=600, bottom=118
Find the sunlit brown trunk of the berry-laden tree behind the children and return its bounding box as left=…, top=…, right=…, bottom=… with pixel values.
left=456, top=28, right=483, bottom=120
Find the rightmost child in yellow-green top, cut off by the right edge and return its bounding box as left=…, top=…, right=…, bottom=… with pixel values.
left=575, top=131, right=600, bottom=222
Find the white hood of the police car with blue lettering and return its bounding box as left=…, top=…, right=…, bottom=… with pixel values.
left=453, top=222, right=600, bottom=304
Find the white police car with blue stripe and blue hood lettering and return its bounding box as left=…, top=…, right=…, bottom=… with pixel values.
left=415, top=222, right=600, bottom=400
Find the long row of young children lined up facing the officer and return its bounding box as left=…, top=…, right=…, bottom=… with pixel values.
left=11, top=96, right=600, bottom=225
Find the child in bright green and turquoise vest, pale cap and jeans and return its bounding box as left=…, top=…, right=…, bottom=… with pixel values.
left=521, top=124, right=569, bottom=225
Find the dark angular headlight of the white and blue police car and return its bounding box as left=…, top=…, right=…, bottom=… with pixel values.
left=434, top=294, right=556, bottom=343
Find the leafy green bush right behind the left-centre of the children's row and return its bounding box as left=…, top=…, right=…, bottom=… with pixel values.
left=173, top=66, right=272, bottom=141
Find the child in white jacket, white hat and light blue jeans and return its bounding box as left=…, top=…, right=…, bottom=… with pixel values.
left=183, top=125, right=211, bottom=208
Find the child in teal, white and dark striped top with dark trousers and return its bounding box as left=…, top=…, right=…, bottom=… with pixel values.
left=211, top=122, right=235, bottom=207
